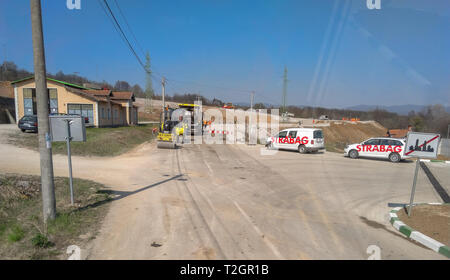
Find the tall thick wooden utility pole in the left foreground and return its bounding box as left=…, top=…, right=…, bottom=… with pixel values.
left=30, top=0, right=56, bottom=223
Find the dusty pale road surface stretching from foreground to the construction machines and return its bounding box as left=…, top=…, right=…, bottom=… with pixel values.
left=0, top=124, right=449, bottom=259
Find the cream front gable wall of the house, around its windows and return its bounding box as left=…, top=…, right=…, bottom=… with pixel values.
left=15, top=80, right=97, bottom=124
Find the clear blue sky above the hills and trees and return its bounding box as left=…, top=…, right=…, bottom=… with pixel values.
left=0, top=0, right=450, bottom=107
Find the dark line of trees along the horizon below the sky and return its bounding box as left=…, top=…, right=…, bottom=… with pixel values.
left=0, top=58, right=450, bottom=137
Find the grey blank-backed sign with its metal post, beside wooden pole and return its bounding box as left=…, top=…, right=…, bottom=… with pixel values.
left=49, top=115, right=86, bottom=205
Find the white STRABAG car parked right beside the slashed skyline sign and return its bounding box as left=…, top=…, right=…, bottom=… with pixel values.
left=344, top=137, right=409, bottom=162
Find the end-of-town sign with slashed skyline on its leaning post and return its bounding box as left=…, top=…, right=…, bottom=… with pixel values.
left=404, top=132, right=441, bottom=217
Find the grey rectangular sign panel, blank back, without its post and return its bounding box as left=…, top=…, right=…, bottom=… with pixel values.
left=49, top=115, right=86, bottom=142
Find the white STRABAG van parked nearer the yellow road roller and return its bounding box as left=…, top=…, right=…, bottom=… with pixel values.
left=266, top=128, right=325, bottom=154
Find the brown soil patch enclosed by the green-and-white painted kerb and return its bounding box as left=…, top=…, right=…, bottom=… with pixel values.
left=397, top=204, right=450, bottom=246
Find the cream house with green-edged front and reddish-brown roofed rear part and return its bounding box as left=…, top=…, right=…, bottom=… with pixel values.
left=11, top=77, right=138, bottom=127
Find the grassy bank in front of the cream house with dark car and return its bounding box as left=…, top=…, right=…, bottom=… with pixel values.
left=9, top=124, right=155, bottom=156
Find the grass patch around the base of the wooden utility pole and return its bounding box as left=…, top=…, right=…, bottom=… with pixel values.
left=0, top=174, right=111, bottom=259
